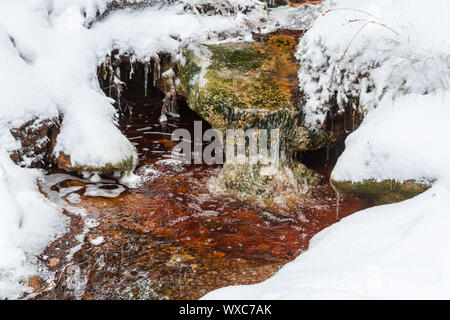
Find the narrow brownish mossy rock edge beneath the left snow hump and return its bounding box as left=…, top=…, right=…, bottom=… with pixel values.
left=57, top=152, right=138, bottom=172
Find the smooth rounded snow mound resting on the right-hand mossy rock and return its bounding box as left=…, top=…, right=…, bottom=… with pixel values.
left=331, top=91, right=450, bottom=182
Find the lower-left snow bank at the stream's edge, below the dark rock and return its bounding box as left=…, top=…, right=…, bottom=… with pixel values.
left=0, top=134, right=66, bottom=299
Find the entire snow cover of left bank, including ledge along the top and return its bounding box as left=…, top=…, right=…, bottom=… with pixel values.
left=0, top=0, right=284, bottom=299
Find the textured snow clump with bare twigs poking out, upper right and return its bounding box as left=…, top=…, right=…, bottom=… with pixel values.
left=297, top=0, right=450, bottom=129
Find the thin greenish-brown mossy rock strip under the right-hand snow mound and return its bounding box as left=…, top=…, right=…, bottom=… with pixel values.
left=330, top=179, right=431, bottom=204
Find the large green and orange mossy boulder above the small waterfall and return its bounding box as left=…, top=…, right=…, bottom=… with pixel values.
left=177, top=32, right=329, bottom=151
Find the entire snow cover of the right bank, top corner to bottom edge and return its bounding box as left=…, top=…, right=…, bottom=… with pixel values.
left=205, top=0, right=450, bottom=299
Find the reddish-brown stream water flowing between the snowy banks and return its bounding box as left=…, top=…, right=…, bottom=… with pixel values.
left=37, top=87, right=368, bottom=299
